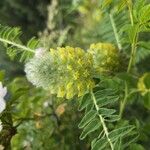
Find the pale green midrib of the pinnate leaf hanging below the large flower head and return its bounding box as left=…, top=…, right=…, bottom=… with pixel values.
left=91, top=91, right=114, bottom=150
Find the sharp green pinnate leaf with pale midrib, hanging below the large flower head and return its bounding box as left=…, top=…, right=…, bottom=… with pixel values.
left=78, top=84, right=134, bottom=150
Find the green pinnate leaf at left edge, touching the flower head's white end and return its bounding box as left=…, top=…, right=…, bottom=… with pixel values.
left=0, top=26, right=38, bottom=61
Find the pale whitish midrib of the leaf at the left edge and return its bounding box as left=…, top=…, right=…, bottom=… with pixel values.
left=0, top=38, right=35, bottom=53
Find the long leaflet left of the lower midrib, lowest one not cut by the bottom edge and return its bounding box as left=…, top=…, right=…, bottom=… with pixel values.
left=80, top=119, right=100, bottom=140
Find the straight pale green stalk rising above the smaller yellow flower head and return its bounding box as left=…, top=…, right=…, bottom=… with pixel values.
left=109, top=13, right=122, bottom=50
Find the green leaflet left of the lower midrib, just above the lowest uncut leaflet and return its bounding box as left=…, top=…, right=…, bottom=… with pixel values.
left=78, top=110, right=97, bottom=128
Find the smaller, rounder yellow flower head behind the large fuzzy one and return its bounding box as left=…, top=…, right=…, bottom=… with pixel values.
left=88, top=43, right=119, bottom=74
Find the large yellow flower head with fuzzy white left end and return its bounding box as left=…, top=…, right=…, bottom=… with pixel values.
left=25, top=46, right=94, bottom=99
